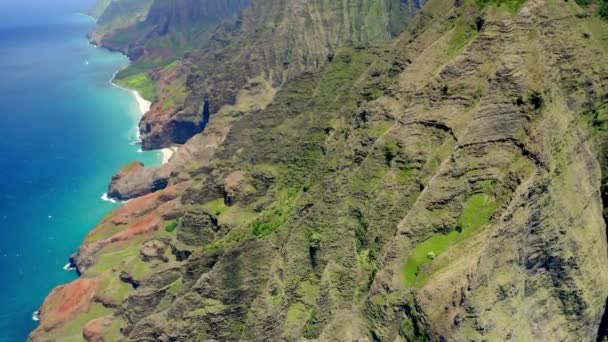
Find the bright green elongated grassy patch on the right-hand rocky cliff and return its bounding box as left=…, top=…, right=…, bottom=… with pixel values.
left=404, top=194, right=499, bottom=286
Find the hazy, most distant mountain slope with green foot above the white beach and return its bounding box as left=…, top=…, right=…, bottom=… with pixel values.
left=89, top=0, right=250, bottom=105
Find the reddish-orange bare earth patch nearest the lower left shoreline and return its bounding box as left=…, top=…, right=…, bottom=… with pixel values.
left=38, top=278, right=101, bottom=332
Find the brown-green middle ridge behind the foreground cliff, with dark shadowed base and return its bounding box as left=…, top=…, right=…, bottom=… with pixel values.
left=134, top=0, right=416, bottom=149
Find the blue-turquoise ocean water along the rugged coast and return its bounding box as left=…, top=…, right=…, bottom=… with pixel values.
left=0, top=0, right=160, bottom=342
